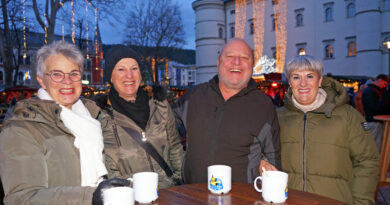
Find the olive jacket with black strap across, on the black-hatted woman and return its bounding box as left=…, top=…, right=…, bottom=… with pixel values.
left=94, top=95, right=184, bottom=188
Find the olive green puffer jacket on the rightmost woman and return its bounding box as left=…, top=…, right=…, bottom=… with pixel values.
left=278, top=77, right=379, bottom=204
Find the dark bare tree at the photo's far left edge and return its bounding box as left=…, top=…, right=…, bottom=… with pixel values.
left=0, top=0, right=23, bottom=88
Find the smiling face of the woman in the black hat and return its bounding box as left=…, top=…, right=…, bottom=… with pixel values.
left=111, top=58, right=142, bottom=101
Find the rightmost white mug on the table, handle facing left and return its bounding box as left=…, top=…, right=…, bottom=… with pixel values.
left=253, top=171, right=288, bottom=203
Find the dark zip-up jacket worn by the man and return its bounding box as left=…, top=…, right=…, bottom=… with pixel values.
left=174, top=76, right=280, bottom=183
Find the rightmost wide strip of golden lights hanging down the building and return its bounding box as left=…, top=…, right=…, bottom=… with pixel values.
left=273, top=0, right=287, bottom=73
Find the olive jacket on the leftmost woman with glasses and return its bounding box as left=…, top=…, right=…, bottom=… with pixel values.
left=0, top=98, right=106, bottom=205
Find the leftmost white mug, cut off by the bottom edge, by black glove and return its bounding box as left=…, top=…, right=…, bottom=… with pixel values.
left=103, top=187, right=134, bottom=205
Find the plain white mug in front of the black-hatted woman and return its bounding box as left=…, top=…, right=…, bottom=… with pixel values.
left=129, top=172, right=158, bottom=203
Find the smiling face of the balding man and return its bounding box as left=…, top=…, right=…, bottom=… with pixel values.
left=217, top=40, right=253, bottom=91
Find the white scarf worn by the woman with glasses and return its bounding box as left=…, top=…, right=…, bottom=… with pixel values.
left=38, top=88, right=107, bottom=187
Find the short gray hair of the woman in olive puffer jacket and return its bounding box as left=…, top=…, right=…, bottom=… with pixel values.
left=284, top=55, right=324, bottom=79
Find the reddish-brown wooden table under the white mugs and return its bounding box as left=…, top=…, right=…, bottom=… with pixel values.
left=145, top=183, right=344, bottom=205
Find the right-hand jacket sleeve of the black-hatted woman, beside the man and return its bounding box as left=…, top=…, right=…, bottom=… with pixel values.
left=166, top=105, right=184, bottom=181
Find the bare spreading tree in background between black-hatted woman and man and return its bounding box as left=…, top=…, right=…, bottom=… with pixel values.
left=125, top=0, right=184, bottom=83
